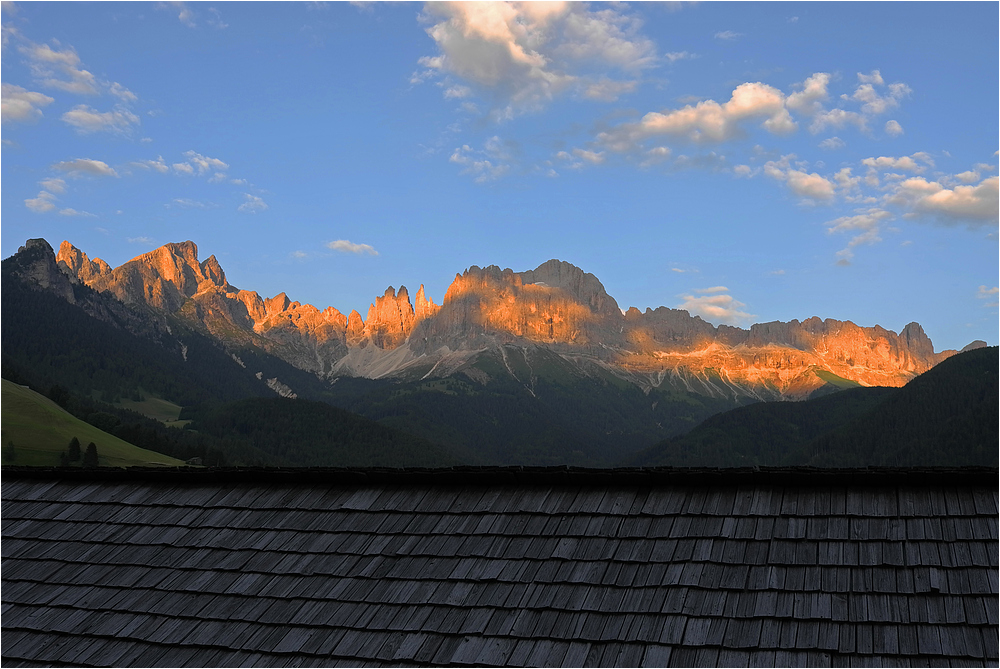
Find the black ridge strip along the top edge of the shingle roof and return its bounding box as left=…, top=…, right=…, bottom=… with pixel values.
left=0, top=466, right=1000, bottom=487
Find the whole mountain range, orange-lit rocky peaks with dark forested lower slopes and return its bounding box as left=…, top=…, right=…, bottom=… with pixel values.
left=3, top=240, right=985, bottom=466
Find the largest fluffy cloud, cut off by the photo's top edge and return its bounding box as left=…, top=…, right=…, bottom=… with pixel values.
left=411, top=2, right=658, bottom=118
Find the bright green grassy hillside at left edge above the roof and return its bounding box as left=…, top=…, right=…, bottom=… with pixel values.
left=0, top=379, right=184, bottom=467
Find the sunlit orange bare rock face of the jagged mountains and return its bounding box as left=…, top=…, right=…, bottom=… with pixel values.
left=57, top=242, right=954, bottom=398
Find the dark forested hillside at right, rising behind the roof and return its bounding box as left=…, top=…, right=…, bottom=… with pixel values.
left=628, top=347, right=1000, bottom=467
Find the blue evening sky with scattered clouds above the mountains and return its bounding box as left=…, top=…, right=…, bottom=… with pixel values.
left=0, top=2, right=1000, bottom=350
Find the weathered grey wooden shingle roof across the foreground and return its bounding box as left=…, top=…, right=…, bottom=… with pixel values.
left=2, top=469, right=998, bottom=667
